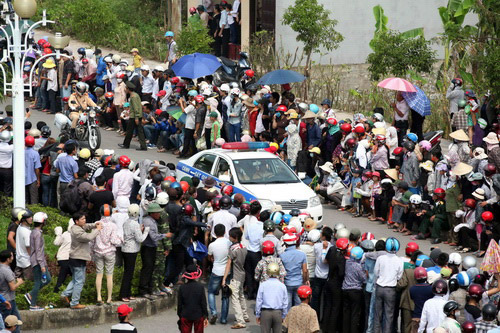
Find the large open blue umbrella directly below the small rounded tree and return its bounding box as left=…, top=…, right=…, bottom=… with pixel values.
left=172, top=53, right=221, bottom=79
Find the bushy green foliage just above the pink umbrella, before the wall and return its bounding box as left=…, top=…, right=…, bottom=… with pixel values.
left=367, top=30, right=435, bottom=80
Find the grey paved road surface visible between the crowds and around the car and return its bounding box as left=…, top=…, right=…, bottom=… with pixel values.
left=17, top=105, right=462, bottom=333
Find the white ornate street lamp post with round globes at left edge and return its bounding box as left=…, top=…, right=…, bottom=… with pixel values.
left=0, top=0, right=69, bottom=208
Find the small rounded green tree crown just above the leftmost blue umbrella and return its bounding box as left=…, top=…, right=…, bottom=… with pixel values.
left=176, top=21, right=214, bottom=56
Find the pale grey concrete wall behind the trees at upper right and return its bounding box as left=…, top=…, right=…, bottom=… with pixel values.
left=276, top=0, right=477, bottom=64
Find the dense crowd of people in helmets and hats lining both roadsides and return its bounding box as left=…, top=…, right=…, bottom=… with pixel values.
left=0, top=18, right=500, bottom=332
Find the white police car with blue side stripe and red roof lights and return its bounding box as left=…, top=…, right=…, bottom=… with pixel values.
left=177, top=143, right=323, bottom=222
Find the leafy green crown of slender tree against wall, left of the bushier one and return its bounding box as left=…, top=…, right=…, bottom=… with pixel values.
left=282, top=0, right=344, bottom=54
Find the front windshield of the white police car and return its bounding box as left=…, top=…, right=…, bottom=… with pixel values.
left=233, top=158, right=300, bottom=184
